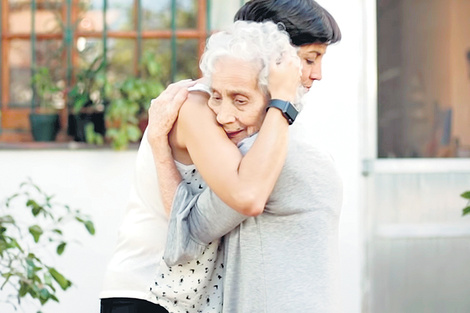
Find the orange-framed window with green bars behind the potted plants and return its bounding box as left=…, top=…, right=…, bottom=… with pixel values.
left=0, top=0, right=208, bottom=142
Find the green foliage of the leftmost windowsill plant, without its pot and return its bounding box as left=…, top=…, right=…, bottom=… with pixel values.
left=31, top=66, right=62, bottom=113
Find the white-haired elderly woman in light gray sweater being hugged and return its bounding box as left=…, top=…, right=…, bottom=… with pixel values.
left=150, top=22, right=341, bottom=313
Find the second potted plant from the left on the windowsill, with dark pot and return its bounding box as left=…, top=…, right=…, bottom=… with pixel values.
left=67, top=56, right=109, bottom=143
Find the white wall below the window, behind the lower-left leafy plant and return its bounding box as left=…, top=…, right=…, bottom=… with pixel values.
left=0, top=150, right=136, bottom=313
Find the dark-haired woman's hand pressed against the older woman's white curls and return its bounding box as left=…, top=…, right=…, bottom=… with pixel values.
left=268, top=47, right=301, bottom=102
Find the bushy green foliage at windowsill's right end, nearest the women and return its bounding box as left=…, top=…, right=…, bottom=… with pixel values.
left=105, top=53, right=164, bottom=150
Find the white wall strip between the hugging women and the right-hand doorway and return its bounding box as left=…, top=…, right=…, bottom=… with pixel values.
left=308, top=0, right=366, bottom=313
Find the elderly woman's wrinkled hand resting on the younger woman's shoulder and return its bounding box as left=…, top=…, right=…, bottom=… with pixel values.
left=147, top=79, right=195, bottom=144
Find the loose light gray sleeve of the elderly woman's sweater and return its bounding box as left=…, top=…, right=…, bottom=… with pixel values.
left=163, top=182, right=248, bottom=266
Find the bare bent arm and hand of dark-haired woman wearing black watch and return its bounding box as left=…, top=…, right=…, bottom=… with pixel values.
left=152, top=53, right=299, bottom=216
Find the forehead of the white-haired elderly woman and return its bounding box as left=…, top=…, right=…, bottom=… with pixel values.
left=211, top=57, right=260, bottom=93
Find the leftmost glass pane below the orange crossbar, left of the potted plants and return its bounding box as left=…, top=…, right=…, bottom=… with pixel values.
left=8, top=40, right=33, bottom=107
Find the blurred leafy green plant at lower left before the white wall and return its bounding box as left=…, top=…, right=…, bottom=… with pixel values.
left=0, top=180, right=95, bottom=312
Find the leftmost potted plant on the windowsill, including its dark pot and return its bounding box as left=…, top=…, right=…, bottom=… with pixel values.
left=29, top=67, right=63, bottom=141
